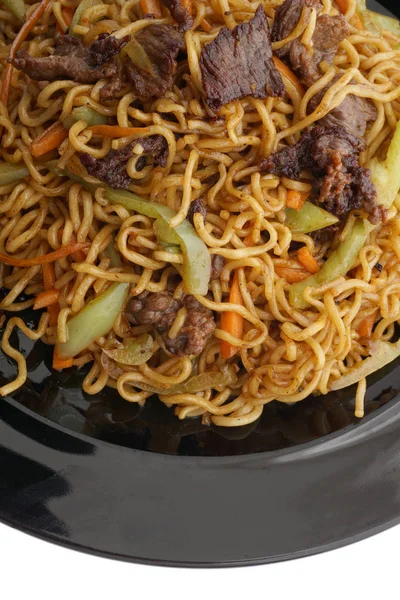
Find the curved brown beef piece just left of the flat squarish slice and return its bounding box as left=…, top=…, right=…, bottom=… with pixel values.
left=125, top=25, right=185, bottom=101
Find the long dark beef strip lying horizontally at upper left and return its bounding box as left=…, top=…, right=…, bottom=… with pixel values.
left=12, top=33, right=130, bottom=83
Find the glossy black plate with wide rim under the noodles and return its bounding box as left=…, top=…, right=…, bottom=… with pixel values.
left=0, top=3, right=400, bottom=566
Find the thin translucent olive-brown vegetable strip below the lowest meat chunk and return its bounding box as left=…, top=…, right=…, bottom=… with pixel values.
left=126, top=365, right=237, bottom=396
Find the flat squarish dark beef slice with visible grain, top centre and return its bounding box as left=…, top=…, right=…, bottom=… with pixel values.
left=200, top=5, right=285, bottom=110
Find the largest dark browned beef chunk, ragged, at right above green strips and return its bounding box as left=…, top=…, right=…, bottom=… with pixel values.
left=261, top=125, right=383, bottom=223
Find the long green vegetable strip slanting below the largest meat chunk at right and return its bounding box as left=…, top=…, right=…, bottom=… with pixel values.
left=289, top=221, right=370, bottom=308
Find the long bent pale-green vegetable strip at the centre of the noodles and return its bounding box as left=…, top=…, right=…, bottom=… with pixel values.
left=104, top=188, right=211, bottom=296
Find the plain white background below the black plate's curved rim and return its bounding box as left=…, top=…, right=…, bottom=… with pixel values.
left=0, top=524, right=400, bottom=600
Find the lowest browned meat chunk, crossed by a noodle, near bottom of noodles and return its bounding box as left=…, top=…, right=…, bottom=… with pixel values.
left=125, top=291, right=215, bottom=356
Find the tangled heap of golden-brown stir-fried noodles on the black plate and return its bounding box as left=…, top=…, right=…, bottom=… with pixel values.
left=0, top=0, right=400, bottom=427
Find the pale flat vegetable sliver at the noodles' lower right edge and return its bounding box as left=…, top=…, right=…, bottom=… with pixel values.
left=331, top=340, right=400, bottom=390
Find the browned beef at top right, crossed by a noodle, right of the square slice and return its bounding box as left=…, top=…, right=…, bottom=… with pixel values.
left=271, top=0, right=349, bottom=87
